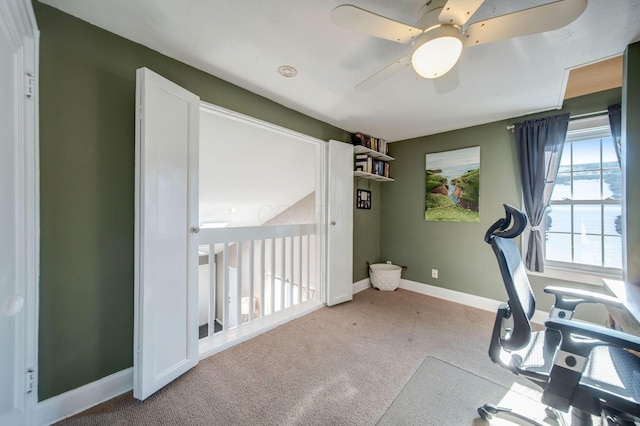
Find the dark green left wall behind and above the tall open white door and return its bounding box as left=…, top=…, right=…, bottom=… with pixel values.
left=33, top=1, right=350, bottom=401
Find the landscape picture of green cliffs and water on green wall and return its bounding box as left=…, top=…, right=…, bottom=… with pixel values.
left=424, top=146, right=480, bottom=222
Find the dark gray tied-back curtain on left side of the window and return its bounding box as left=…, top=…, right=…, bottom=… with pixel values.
left=515, top=114, right=569, bottom=272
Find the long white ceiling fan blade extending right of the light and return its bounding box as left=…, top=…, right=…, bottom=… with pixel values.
left=464, top=0, right=587, bottom=47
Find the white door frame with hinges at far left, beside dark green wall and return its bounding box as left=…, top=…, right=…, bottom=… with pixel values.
left=0, top=0, right=40, bottom=424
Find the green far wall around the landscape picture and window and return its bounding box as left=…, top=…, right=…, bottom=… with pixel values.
left=380, top=89, right=621, bottom=323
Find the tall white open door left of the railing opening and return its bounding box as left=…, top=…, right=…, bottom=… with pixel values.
left=133, top=68, right=200, bottom=400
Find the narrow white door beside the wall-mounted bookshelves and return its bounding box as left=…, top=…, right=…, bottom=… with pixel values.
left=326, top=141, right=354, bottom=306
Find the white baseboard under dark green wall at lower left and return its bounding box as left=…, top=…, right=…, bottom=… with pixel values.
left=32, top=367, right=133, bottom=426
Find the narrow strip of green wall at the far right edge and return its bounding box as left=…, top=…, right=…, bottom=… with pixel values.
left=622, top=42, right=640, bottom=285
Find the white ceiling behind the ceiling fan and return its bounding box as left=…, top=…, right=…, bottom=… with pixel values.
left=41, top=0, right=640, bottom=141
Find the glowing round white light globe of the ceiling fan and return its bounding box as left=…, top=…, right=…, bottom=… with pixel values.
left=411, top=25, right=462, bottom=78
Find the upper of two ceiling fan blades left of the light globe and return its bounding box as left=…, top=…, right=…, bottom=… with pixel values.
left=331, top=4, right=422, bottom=43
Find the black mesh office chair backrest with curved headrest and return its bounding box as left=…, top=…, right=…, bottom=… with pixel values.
left=484, top=204, right=536, bottom=350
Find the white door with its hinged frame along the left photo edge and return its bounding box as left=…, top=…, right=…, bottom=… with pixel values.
left=0, top=0, right=38, bottom=425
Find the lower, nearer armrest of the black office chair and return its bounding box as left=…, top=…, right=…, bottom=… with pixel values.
left=544, top=318, right=640, bottom=356
